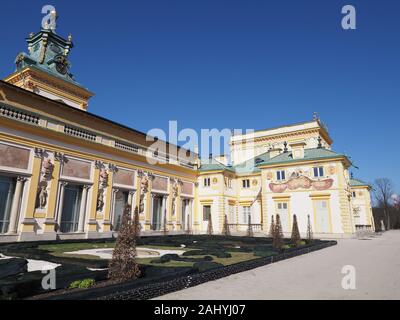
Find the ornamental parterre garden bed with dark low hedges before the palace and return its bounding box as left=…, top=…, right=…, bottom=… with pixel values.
left=0, top=235, right=336, bottom=299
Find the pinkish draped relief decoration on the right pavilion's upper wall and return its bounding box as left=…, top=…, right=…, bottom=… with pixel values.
left=269, top=175, right=333, bottom=193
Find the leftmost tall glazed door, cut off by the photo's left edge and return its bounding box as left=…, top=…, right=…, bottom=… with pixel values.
left=0, top=176, right=15, bottom=234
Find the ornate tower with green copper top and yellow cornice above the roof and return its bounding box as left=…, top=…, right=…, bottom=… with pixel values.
left=4, top=12, right=93, bottom=111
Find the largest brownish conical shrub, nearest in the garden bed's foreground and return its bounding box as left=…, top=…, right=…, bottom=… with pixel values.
left=108, top=206, right=140, bottom=282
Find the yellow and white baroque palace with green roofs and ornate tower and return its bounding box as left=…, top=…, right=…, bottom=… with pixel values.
left=0, top=19, right=374, bottom=242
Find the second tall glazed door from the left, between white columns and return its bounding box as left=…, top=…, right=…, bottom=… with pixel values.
left=60, top=184, right=82, bottom=233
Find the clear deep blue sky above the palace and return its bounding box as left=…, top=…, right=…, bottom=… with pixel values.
left=0, top=0, right=400, bottom=190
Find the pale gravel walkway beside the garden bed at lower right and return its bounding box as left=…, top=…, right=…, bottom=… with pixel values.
left=155, top=231, right=400, bottom=300
